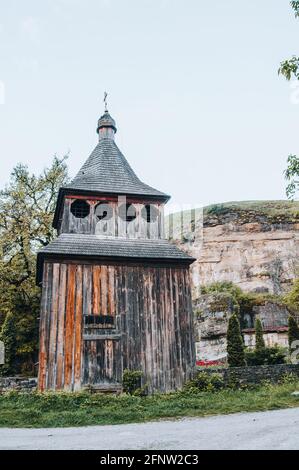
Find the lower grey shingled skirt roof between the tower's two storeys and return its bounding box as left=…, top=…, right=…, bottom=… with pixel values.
left=37, top=233, right=195, bottom=282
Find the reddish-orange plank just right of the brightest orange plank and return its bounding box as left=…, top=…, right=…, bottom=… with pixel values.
left=73, top=265, right=83, bottom=390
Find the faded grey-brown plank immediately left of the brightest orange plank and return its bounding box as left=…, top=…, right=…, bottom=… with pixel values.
left=55, top=264, right=67, bottom=390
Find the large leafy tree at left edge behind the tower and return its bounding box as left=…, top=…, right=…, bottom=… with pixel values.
left=0, top=157, right=67, bottom=374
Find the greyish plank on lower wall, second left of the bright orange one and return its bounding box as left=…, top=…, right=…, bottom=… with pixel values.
left=47, top=263, right=60, bottom=390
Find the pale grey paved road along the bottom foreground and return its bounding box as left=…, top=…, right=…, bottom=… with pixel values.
left=0, top=408, right=299, bottom=450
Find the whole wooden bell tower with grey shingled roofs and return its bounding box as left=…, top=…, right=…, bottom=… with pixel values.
left=37, top=103, right=195, bottom=393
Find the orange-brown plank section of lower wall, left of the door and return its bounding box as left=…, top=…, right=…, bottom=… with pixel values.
left=39, top=263, right=84, bottom=391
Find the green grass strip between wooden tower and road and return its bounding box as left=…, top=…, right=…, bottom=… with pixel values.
left=0, top=381, right=299, bottom=428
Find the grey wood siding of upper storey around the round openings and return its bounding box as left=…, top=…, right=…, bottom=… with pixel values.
left=58, top=198, right=164, bottom=239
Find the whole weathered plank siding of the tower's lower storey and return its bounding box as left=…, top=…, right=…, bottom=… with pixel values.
left=39, top=262, right=195, bottom=392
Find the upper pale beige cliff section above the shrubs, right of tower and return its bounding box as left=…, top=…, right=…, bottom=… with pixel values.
left=174, top=201, right=299, bottom=294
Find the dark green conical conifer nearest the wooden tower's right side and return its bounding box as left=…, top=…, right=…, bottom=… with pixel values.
left=227, top=314, right=246, bottom=367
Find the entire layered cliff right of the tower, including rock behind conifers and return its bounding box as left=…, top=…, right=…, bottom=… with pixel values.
left=166, top=201, right=299, bottom=365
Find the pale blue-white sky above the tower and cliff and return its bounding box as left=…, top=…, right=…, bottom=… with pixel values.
left=0, top=0, right=299, bottom=209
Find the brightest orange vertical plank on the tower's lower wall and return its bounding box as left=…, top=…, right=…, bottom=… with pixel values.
left=64, top=264, right=76, bottom=390
